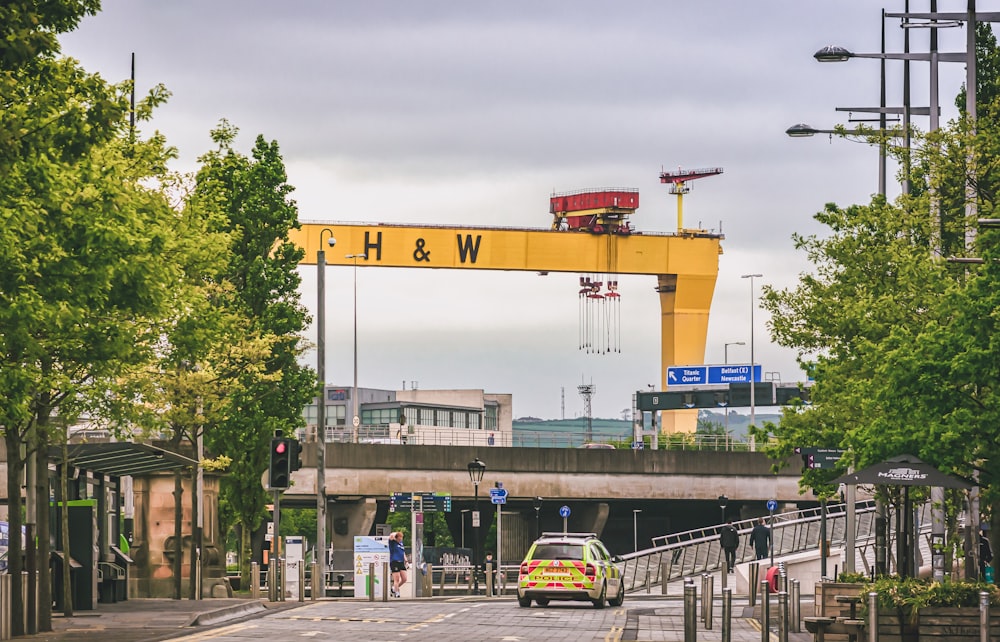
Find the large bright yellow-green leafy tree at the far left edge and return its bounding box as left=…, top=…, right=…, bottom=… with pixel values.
left=0, top=63, right=177, bottom=631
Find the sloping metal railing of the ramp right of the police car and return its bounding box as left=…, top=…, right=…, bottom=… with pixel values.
left=619, top=500, right=900, bottom=591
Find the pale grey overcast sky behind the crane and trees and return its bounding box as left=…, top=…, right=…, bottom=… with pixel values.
left=62, top=0, right=980, bottom=419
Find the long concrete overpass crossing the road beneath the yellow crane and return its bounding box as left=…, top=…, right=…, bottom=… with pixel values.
left=282, top=443, right=815, bottom=557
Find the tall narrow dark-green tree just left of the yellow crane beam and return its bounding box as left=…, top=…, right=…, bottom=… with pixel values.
left=191, top=121, right=317, bottom=578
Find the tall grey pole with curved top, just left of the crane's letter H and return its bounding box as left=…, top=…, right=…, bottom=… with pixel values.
left=313, top=228, right=337, bottom=597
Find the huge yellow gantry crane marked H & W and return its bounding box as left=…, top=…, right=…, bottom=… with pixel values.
left=290, top=186, right=724, bottom=433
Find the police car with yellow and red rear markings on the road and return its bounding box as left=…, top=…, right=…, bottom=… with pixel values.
left=517, top=533, right=625, bottom=609
